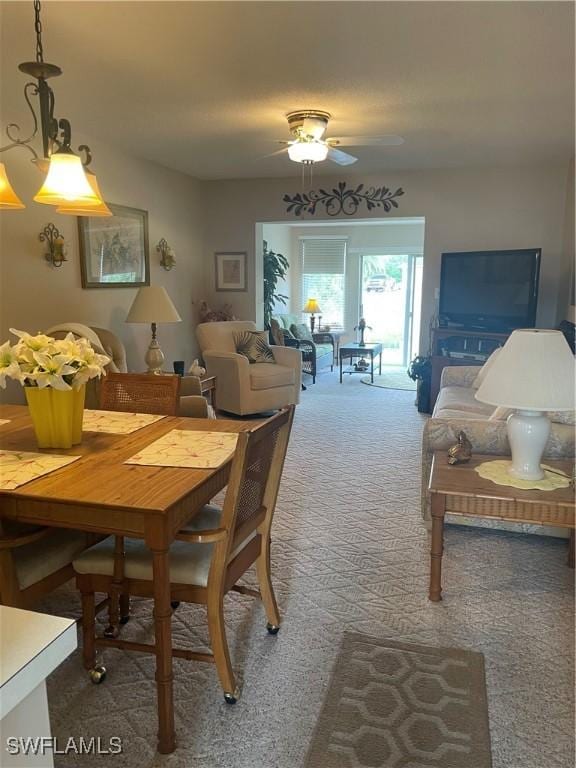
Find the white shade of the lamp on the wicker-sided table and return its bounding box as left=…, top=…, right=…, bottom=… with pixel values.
left=476, top=328, right=576, bottom=411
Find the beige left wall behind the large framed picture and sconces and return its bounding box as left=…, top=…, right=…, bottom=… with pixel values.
left=0, top=135, right=205, bottom=402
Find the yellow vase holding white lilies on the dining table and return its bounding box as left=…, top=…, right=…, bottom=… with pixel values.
left=24, top=385, right=86, bottom=448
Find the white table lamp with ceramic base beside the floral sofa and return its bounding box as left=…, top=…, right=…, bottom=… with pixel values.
left=476, top=328, right=575, bottom=480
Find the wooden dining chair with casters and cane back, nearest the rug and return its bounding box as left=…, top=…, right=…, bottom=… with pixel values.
left=74, top=406, right=294, bottom=704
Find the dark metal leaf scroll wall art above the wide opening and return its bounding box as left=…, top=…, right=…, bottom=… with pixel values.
left=283, top=181, right=404, bottom=216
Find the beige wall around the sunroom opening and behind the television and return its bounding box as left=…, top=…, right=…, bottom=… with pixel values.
left=203, top=163, right=568, bottom=349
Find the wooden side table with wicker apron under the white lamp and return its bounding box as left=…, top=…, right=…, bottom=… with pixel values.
left=428, top=451, right=575, bottom=602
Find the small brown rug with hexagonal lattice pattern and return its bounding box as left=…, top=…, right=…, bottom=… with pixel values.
left=306, top=632, right=492, bottom=768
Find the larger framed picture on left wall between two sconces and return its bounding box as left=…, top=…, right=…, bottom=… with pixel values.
left=78, top=204, right=150, bottom=288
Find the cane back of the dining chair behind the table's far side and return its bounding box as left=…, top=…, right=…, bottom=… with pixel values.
left=100, top=373, right=180, bottom=416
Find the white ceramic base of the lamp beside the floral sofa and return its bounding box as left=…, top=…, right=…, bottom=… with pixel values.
left=507, top=411, right=550, bottom=480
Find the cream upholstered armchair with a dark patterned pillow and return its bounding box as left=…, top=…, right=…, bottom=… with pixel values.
left=196, top=320, right=302, bottom=416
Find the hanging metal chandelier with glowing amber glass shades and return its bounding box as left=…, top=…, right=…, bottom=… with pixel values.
left=0, top=0, right=112, bottom=216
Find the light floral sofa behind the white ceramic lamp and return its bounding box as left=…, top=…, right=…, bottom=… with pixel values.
left=421, top=366, right=575, bottom=536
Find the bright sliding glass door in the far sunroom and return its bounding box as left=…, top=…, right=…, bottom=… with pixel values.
left=360, top=254, right=422, bottom=366
